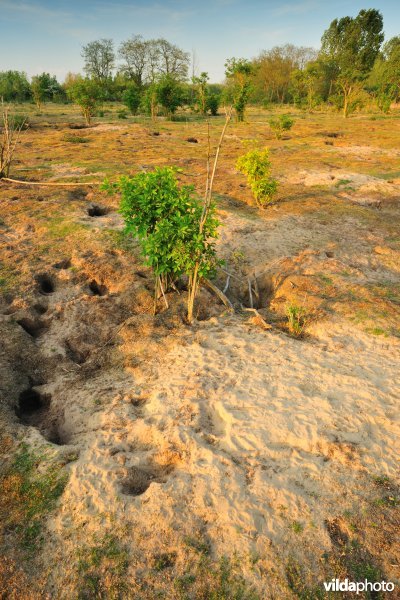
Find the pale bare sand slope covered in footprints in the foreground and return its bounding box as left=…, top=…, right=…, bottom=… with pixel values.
left=36, top=308, right=400, bottom=592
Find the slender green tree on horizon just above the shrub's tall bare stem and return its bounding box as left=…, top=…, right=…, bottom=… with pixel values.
left=225, top=58, right=254, bottom=122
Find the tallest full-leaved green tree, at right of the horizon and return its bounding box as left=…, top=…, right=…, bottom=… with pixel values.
left=321, top=9, right=384, bottom=117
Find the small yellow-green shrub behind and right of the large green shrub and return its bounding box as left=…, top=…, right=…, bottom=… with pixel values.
left=236, top=148, right=278, bottom=207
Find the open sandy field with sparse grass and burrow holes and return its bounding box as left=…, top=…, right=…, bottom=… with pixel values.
left=0, top=105, right=400, bottom=600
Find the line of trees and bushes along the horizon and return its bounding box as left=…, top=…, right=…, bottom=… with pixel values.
left=0, top=9, right=400, bottom=122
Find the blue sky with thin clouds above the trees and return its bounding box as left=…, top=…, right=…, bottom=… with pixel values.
left=0, top=0, right=400, bottom=82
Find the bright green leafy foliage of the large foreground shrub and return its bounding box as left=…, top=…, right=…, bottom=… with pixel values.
left=104, top=167, right=218, bottom=312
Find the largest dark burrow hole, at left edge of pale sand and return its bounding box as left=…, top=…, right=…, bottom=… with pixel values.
left=15, top=387, right=66, bottom=446
